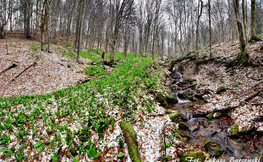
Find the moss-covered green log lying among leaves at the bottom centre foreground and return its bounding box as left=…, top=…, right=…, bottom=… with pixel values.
left=120, top=121, right=141, bottom=162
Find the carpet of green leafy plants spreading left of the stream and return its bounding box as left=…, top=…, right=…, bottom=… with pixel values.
left=0, top=51, right=165, bottom=161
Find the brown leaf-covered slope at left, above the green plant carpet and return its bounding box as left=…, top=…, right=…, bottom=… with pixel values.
left=0, top=38, right=95, bottom=97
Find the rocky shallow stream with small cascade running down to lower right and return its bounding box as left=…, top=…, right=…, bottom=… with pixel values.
left=168, top=72, right=263, bottom=160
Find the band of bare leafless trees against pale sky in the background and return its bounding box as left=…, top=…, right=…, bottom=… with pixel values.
left=0, top=0, right=263, bottom=61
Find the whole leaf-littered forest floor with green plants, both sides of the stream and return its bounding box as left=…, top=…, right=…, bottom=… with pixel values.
left=0, top=38, right=263, bottom=162
